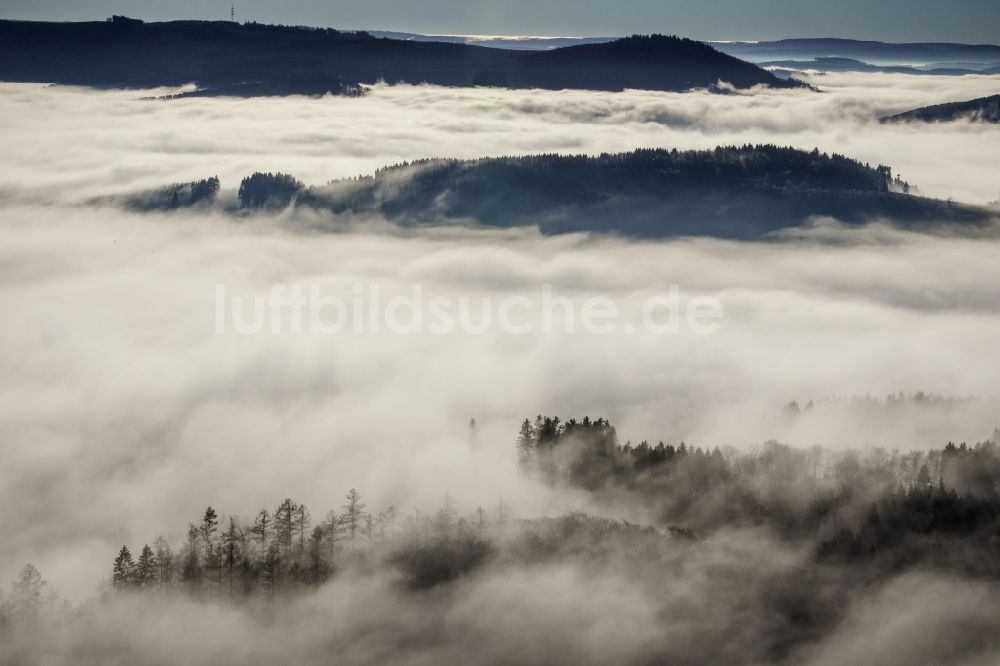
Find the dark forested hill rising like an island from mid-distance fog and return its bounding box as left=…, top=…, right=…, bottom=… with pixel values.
left=217, top=145, right=985, bottom=238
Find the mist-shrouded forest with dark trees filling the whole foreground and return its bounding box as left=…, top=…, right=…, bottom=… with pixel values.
left=0, top=416, right=1000, bottom=664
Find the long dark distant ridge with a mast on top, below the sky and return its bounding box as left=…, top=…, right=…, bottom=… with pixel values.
left=0, top=17, right=801, bottom=92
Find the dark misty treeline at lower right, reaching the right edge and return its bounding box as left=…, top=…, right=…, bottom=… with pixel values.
left=516, top=416, right=1000, bottom=576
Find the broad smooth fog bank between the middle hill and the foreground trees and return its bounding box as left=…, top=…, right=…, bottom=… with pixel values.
left=0, top=207, right=1000, bottom=589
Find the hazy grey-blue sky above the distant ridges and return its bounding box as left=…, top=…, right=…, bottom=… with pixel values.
left=0, top=0, right=1000, bottom=43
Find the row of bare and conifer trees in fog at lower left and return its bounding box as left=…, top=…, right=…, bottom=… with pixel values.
left=111, top=489, right=510, bottom=599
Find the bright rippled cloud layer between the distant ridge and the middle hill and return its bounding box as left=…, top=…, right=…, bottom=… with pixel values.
left=0, top=74, right=1000, bottom=204
